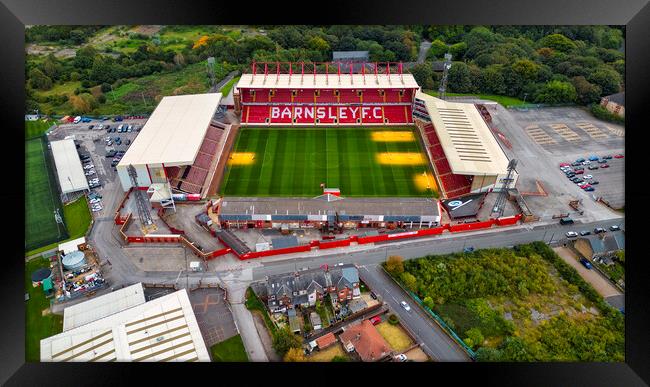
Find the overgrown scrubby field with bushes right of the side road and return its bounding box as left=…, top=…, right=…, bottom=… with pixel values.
left=386, top=242, right=625, bottom=361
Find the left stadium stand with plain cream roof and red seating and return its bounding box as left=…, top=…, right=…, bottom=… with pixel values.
left=117, top=93, right=230, bottom=201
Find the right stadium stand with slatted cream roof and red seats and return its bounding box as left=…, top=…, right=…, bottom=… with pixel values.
left=413, top=91, right=517, bottom=198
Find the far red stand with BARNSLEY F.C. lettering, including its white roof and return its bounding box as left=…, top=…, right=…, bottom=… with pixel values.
left=234, top=62, right=419, bottom=126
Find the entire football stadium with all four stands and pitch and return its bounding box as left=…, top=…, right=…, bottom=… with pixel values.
left=117, top=63, right=517, bottom=233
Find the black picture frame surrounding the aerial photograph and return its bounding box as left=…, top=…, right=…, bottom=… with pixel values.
left=0, top=0, right=650, bottom=386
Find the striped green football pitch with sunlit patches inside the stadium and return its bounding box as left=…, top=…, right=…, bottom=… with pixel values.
left=221, top=127, right=437, bottom=197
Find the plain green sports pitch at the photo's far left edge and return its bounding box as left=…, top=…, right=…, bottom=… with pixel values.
left=25, top=137, right=68, bottom=251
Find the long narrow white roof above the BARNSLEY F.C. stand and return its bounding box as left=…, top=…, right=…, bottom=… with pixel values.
left=237, top=73, right=420, bottom=89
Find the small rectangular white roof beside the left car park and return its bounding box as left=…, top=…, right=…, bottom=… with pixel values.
left=50, top=138, right=88, bottom=194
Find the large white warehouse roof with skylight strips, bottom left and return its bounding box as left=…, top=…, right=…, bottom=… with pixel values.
left=41, top=289, right=210, bottom=362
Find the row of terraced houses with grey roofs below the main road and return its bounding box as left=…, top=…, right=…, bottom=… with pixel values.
left=266, top=264, right=361, bottom=313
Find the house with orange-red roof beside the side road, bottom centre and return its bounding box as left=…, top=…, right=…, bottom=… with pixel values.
left=339, top=319, right=391, bottom=362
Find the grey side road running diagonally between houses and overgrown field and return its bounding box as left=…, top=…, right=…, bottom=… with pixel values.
left=359, top=264, right=470, bottom=361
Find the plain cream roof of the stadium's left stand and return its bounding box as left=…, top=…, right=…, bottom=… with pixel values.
left=118, top=93, right=221, bottom=168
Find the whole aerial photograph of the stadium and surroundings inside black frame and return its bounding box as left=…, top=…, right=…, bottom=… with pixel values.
left=21, top=25, right=632, bottom=362
